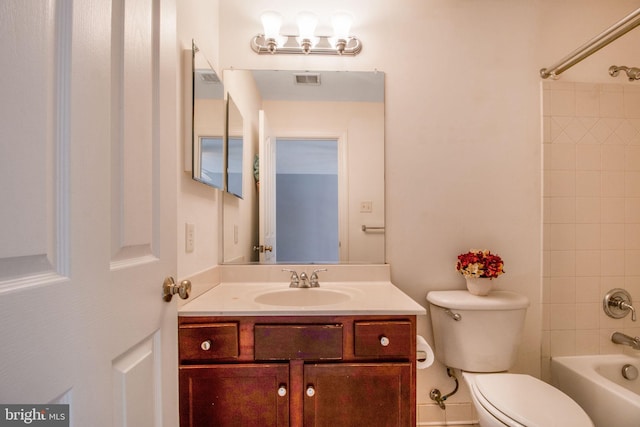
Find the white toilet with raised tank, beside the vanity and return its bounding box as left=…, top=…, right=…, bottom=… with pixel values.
left=427, top=290, right=593, bottom=427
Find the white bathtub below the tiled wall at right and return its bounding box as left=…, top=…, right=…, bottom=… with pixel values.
left=551, top=354, right=640, bottom=427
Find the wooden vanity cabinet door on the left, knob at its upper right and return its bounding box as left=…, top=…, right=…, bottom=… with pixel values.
left=180, top=363, right=290, bottom=427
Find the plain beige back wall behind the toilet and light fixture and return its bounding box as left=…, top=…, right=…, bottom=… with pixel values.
left=179, top=0, right=640, bottom=421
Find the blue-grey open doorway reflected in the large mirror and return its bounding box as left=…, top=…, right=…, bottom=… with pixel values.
left=275, top=138, right=340, bottom=263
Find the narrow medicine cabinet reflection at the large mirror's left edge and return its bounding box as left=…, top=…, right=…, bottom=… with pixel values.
left=227, top=96, right=244, bottom=198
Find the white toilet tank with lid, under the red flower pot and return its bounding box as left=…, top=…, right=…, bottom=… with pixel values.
left=427, top=290, right=529, bottom=372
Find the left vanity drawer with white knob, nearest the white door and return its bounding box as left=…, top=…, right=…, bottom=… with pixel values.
left=178, top=323, right=239, bottom=362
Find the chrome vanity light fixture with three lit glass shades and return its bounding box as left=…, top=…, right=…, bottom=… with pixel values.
left=251, top=11, right=362, bottom=56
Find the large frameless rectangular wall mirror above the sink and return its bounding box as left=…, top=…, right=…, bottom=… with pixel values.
left=222, top=70, right=385, bottom=264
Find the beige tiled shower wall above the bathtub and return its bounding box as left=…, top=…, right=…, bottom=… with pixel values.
left=541, top=82, right=640, bottom=380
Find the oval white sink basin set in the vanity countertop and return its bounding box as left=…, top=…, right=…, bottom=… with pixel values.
left=254, top=288, right=352, bottom=307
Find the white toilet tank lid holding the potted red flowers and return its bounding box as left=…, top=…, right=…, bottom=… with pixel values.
left=427, top=290, right=529, bottom=310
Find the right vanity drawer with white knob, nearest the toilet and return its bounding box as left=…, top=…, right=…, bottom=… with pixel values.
left=354, top=321, right=415, bottom=357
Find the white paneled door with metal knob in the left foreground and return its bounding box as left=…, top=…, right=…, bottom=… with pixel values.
left=0, top=0, right=178, bottom=427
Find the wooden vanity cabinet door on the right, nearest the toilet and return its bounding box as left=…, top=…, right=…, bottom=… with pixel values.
left=303, top=362, right=412, bottom=427
